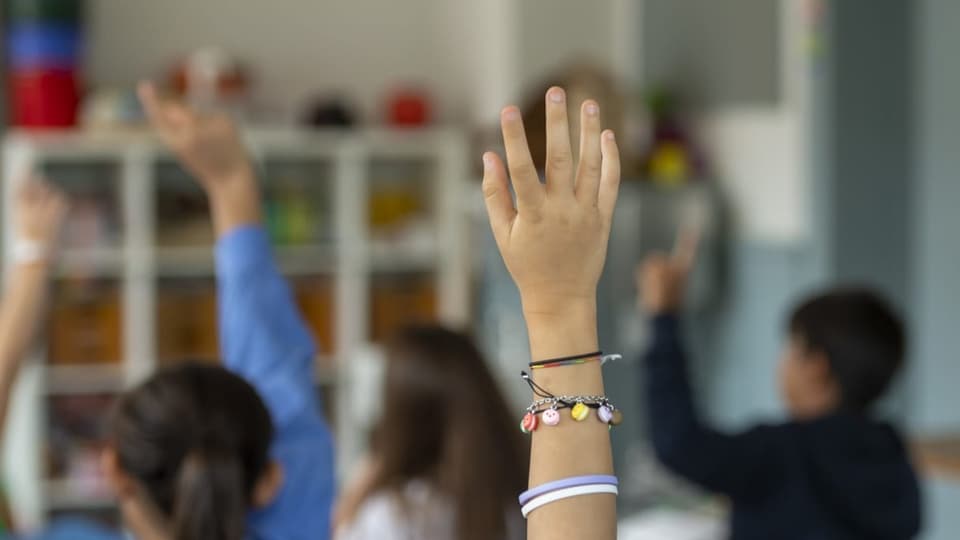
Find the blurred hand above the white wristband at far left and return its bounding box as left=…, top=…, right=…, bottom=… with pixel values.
left=16, top=178, right=68, bottom=250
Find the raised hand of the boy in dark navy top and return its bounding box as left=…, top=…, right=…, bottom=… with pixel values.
left=636, top=229, right=700, bottom=315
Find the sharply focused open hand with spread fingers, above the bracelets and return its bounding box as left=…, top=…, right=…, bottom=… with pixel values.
left=483, top=88, right=620, bottom=316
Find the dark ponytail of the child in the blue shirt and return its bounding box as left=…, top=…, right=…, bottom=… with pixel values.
left=171, top=451, right=248, bottom=540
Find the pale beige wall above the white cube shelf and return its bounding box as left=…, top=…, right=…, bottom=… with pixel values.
left=87, top=0, right=632, bottom=123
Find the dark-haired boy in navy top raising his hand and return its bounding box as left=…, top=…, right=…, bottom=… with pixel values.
left=638, top=234, right=921, bottom=540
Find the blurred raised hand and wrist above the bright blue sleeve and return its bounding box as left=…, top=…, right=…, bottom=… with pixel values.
left=138, top=82, right=261, bottom=236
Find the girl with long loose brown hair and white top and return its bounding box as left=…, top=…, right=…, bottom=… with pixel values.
left=335, top=326, right=527, bottom=540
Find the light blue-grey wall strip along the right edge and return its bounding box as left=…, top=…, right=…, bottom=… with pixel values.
left=912, top=0, right=960, bottom=434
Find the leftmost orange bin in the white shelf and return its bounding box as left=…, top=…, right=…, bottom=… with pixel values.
left=48, top=283, right=123, bottom=365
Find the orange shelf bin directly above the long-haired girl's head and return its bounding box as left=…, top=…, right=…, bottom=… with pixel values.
left=370, top=274, right=437, bottom=342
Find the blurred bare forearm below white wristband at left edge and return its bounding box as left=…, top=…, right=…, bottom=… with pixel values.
left=0, top=263, right=47, bottom=433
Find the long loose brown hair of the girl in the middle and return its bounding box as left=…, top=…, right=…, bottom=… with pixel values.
left=370, top=326, right=527, bottom=540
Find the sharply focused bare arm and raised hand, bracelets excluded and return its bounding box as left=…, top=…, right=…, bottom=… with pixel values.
left=483, top=88, right=620, bottom=540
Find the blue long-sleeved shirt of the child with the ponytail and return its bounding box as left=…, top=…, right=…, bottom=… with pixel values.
left=17, top=226, right=334, bottom=540
